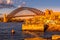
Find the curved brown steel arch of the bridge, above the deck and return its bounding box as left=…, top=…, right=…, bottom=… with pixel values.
left=7, top=7, right=44, bottom=17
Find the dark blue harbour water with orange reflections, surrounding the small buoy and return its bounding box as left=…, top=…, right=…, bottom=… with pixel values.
left=0, top=22, right=60, bottom=40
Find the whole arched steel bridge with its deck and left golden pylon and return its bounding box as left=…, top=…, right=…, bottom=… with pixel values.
left=4, top=7, right=44, bottom=21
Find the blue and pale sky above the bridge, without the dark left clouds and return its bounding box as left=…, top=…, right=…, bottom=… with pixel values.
left=0, top=0, right=60, bottom=13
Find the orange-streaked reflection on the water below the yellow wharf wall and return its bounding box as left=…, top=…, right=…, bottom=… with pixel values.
left=22, top=31, right=43, bottom=40
